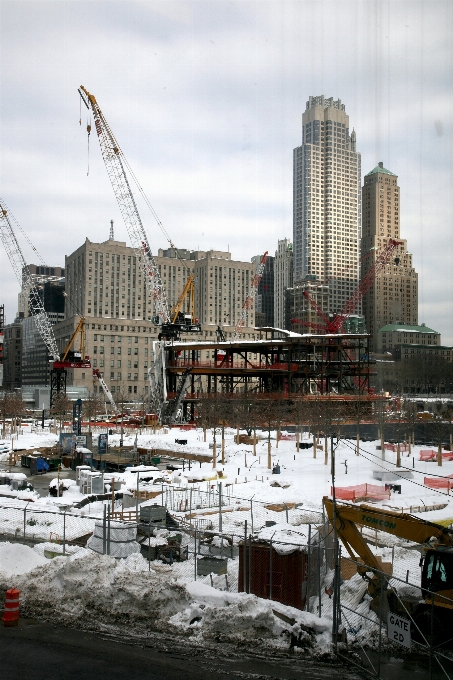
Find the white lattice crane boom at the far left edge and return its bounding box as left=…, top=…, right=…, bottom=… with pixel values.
left=0, top=198, right=60, bottom=361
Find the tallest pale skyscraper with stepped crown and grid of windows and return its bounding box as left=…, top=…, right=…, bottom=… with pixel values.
left=293, top=96, right=361, bottom=313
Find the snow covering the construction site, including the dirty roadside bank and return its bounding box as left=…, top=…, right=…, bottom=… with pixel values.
left=0, top=428, right=453, bottom=649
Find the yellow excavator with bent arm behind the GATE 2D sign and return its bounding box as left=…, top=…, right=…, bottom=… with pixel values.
left=323, top=496, right=453, bottom=637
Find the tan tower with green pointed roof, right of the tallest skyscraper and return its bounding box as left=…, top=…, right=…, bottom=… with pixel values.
left=362, top=163, right=418, bottom=351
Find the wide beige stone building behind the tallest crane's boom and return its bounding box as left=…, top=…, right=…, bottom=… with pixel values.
left=55, top=238, right=256, bottom=400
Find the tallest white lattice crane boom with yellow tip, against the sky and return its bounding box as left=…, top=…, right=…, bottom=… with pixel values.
left=79, top=85, right=169, bottom=324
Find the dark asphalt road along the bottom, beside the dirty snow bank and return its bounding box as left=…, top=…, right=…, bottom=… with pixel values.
left=0, top=619, right=360, bottom=680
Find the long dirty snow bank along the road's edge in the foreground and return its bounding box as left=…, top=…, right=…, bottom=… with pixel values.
left=0, top=544, right=331, bottom=653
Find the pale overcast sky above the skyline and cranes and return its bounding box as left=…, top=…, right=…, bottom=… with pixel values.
left=0, top=0, right=453, bottom=344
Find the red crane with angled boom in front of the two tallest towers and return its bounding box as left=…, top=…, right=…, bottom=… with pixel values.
left=291, top=239, right=403, bottom=333
